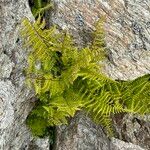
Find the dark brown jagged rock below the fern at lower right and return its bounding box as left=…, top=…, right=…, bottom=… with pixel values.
left=113, top=114, right=150, bottom=149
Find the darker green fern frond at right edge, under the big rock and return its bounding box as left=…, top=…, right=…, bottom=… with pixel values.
left=123, top=74, right=150, bottom=115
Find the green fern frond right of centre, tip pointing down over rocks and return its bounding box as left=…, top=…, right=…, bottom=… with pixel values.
left=74, top=76, right=125, bottom=135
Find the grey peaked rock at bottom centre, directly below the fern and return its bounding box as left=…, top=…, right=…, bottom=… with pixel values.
left=55, top=113, right=110, bottom=150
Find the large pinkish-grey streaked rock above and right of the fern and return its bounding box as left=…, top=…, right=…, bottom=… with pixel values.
left=51, top=0, right=150, bottom=80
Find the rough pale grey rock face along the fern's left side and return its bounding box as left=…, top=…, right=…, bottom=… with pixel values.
left=0, top=0, right=49, bottom=150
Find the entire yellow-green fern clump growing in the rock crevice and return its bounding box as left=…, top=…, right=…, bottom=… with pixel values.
left=21, top=16, right=150, bottom=136
